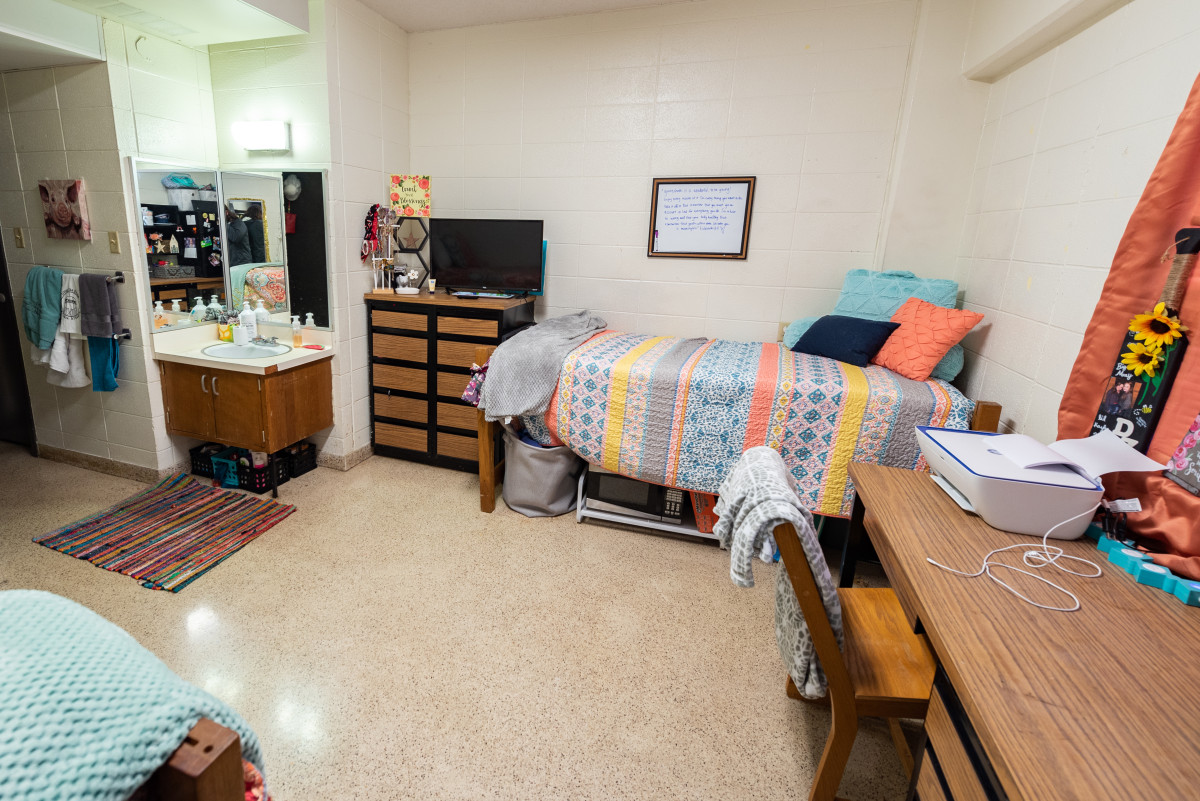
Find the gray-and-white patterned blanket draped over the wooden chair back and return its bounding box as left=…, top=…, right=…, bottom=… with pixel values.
left=713, top=446, right=842, bottom=698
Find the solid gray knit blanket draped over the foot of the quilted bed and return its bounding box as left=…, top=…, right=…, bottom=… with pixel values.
left=479, top=309, right=608, bottom=420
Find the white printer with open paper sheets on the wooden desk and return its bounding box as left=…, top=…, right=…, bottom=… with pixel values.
left=917, top=426, right=1164, bottom=540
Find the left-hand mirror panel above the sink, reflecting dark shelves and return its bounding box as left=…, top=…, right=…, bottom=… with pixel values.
left=131, top=158, right=226, bottom=331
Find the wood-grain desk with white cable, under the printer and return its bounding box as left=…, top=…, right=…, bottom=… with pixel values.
left=850, top=464, right=1200, bottom=801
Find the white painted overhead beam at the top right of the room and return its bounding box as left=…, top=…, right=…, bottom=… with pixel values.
left=962, top=0, right=1129, bottom=83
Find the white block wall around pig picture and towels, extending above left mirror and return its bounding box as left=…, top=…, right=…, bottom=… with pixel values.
left=0, top=22, right=216, bottom=469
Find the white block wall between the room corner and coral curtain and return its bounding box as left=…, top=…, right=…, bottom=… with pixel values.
left=958, top=0, right=1200, bottom=442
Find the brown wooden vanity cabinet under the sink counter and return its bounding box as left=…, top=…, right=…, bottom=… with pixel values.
left=158, top=356, right=334, bottom=453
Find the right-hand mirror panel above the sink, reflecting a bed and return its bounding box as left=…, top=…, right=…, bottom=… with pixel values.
left=218, top=171, right=330, bottom=329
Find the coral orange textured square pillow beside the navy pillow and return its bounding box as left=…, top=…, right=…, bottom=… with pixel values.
left=871, top=297, right=983, bottom=381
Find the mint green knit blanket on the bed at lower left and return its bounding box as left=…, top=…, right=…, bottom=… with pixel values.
left=0, top=590, right=265, bottom=801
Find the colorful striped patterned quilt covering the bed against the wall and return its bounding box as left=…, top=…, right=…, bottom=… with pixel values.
left=524, top=331, right=974, bottom=517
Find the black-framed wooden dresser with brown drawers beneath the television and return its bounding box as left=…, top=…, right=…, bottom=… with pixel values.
left=365, top=290, right=534, bottom=472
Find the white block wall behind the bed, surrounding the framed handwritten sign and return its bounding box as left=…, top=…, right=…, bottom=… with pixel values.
left=409, top=0, right=921, bottom=341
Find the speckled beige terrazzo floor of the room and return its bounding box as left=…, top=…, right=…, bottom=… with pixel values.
left=0, top=445, right=907, bottom=801
